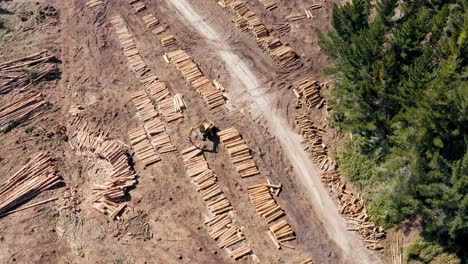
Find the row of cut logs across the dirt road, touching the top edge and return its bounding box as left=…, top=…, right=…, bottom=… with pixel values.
left=220, top=0, right=299, bottom=68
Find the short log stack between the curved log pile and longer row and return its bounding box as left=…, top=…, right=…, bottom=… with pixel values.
left=128, top=127, right=161, bottom=167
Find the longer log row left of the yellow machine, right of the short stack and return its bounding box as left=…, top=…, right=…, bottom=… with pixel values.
left=130, top=91, right=177, bottom=154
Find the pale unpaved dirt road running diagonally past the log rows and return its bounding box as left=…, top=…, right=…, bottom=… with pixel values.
left=167, top=0, right=380, bottom=263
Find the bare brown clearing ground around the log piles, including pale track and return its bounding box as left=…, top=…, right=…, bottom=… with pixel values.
left=0, top=0, right=379, bottom=263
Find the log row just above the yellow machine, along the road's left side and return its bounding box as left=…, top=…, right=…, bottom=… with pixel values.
left=167, top=50, right=224, bottom=108
